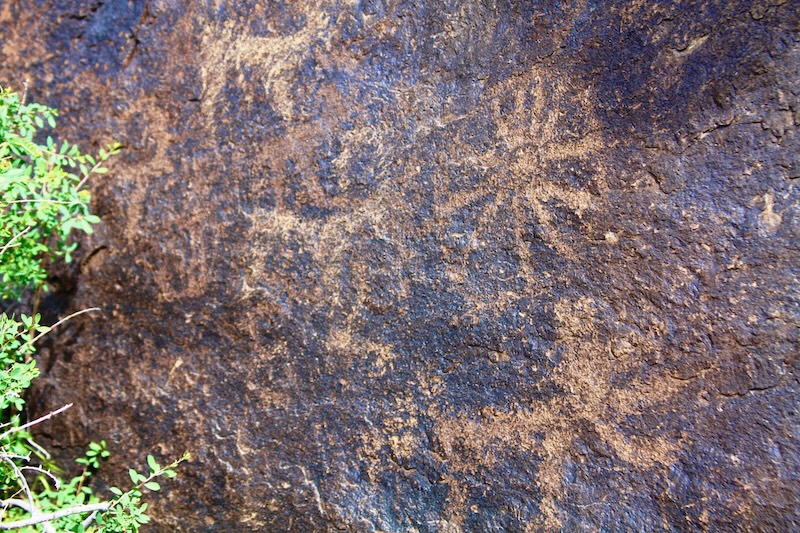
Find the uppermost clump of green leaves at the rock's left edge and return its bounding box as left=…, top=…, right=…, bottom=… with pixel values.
left=0, top=84, right=122, bottom=300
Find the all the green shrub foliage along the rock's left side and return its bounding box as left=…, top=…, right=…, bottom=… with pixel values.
left=0, top=87, right=188, bottom=532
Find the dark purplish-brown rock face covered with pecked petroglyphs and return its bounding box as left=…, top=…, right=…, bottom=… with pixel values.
left=0, top=0, right=800, bottom=532
